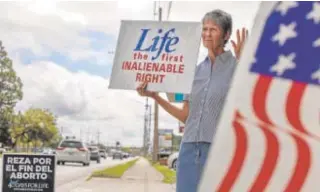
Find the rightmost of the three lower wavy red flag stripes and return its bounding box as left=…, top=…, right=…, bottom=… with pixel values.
left=284, top=134, right=311, bottom=192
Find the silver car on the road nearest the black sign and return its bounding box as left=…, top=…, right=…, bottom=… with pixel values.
left=56, top=139, right=90, bottom=166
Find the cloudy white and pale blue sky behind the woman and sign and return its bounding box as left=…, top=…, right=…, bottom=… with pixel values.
left=0, top=0, right=259, bottom=146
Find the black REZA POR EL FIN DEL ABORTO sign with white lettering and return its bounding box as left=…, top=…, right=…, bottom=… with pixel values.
left=2, top=154, right=56, bottom=192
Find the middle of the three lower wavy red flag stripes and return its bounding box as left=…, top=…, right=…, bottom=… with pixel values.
left=249, top=125, right=280, bottom=192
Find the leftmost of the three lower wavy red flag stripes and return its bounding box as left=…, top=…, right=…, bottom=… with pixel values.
left=217, top=111, right=248, bottom=192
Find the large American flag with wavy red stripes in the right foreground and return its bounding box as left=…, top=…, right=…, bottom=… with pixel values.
left=199, top=1, right=320, bottom=192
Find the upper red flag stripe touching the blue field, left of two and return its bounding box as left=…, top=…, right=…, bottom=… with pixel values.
left=252, top=75, right=273, bottom=125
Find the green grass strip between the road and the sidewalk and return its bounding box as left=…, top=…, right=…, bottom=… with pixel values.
left=87, top=159, right=139, bottom=180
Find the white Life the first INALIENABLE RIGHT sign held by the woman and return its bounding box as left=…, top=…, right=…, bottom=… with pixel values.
left=109, top=21, right=201, bottom=93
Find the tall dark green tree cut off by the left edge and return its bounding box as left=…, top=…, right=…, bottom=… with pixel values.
left=0, top=41, right=23, bottom=144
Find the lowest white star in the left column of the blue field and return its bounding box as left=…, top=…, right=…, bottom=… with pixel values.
left=270, top=53, right=296, bottom=76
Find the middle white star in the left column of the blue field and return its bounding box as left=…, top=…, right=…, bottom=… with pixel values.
left=272, top=22, right=298, bottom=46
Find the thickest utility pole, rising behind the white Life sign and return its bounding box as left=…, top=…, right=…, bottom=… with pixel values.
left=152, top=5, right=162, bottom=162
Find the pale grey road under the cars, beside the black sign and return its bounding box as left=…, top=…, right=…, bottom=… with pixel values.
left=0, top=158, right=132, bottom=191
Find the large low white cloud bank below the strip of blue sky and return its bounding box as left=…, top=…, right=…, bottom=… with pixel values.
left=14, top=56, right=175, bottom=145
